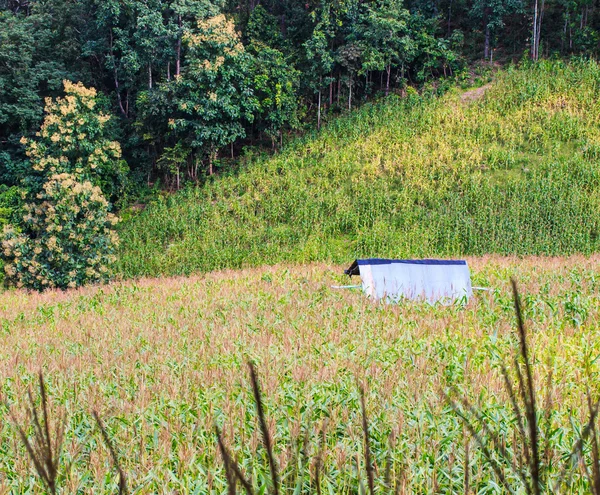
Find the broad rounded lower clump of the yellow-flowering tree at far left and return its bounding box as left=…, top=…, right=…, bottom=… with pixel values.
left=2, top=173, right=117, bottom=290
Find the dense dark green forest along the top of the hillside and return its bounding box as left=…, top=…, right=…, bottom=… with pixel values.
left=0, top=0, right=600, bottom=198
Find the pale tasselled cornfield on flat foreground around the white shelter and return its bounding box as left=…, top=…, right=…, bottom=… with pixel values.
left=0, top=256, right=600, bottom=494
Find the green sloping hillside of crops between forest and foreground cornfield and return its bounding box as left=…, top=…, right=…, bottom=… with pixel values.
left=119, top=61, right=600, bottom=276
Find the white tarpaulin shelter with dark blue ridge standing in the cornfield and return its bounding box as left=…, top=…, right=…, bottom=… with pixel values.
left=345, top=258, right=473, bottom=304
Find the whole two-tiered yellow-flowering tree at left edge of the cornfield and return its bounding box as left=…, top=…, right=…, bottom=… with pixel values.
left=0, top=81, right=121, bottom=290
